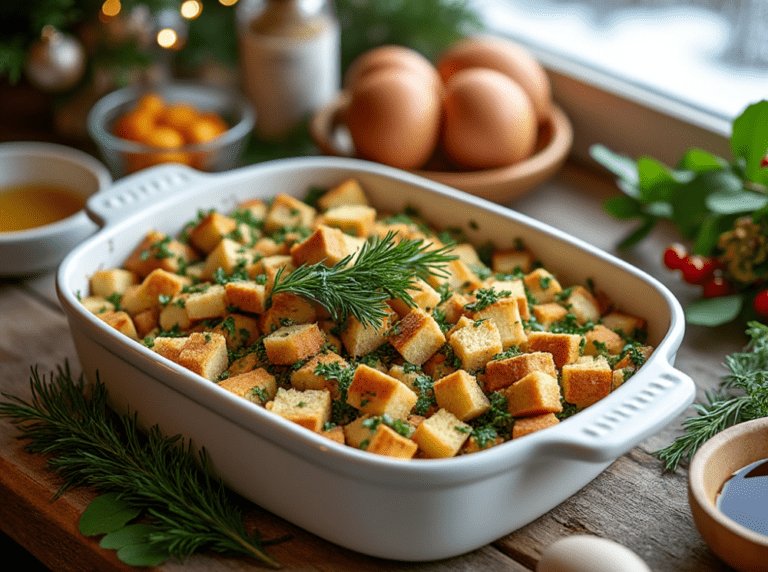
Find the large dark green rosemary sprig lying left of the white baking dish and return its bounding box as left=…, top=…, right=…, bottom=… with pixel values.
left=0, top=364, right=280, bottom=568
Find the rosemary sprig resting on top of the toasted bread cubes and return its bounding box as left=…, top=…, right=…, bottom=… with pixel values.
left=270, top=231, right=456, bottom=326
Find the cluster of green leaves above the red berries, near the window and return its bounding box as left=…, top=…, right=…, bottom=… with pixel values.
left=591, top=100, right=768, bottom=255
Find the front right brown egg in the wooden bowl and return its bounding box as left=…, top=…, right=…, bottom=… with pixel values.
left=441, top=68, right=538, bottom=169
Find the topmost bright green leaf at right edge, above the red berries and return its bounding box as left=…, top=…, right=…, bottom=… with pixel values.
left=731, top=100, right=768, bottom=185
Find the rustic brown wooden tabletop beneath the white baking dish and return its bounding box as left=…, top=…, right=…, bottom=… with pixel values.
left=0, top=158, right=746, bottom=572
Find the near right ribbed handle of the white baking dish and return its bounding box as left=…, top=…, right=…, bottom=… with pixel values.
left=548, top=362, right=696, bottom=462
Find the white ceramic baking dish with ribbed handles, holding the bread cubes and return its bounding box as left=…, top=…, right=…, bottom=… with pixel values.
left=57, top=157, right=695, bottom=560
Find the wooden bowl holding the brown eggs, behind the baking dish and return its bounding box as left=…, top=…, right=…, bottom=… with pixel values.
left=309, top=92, right=573, bottom=203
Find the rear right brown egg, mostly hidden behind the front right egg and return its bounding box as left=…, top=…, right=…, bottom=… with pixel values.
left=437, top=36, right=552, bottom=123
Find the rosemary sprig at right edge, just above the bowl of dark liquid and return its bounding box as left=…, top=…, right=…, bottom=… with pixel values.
left=654, top=322, right=768, bottom=471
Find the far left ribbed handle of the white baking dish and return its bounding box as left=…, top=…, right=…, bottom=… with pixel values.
left=85, top=163, right=212, bottom=227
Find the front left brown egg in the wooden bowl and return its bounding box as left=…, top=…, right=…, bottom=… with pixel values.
left=344, top=68, right=441, bottom=169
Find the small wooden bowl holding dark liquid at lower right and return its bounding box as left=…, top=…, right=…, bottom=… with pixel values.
left=688, top=418, right=768, bottom=572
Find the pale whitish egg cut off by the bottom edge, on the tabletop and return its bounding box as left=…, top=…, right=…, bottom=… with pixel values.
left=536, top=535, right=651, bottom=572
